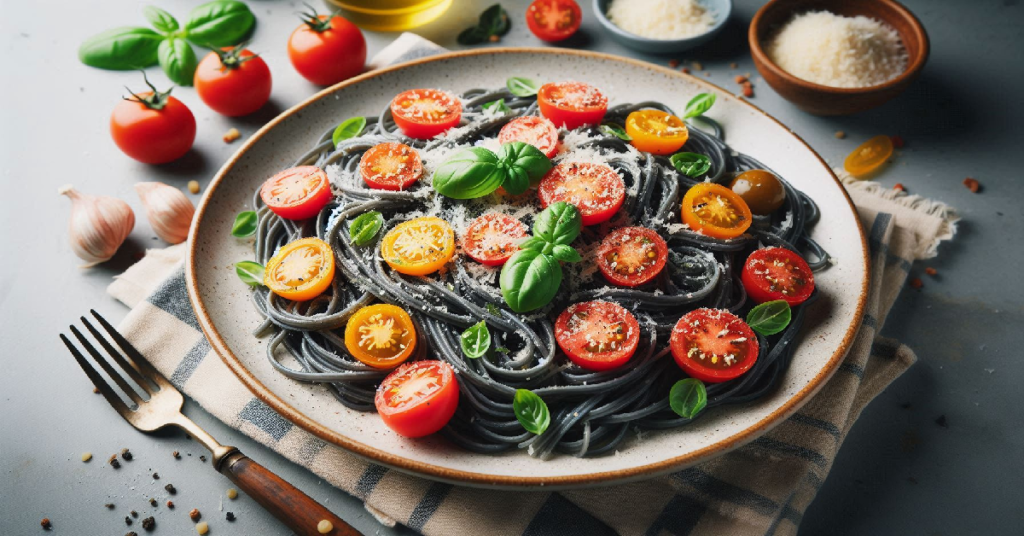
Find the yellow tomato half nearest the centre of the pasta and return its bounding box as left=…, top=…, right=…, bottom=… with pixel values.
left=381, top=216, right=455, bottom=276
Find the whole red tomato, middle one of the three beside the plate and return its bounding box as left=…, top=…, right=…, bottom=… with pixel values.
left=193, top=47, right=272, bottom=117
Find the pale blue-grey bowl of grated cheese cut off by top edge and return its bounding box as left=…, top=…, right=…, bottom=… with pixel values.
left=594, top=0, right=732, bottom=54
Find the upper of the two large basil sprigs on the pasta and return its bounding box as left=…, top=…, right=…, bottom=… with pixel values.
left=432, top=141, right=551, bottom=199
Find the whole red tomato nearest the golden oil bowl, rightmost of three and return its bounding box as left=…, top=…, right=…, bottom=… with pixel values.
left=288, top=12, right=367, bottom=86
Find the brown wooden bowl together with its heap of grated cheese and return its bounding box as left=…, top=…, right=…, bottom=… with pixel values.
left=748, top=0, right=929, bottom=116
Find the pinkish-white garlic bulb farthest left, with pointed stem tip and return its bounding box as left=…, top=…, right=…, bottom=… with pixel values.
left=57, top=184, right=135, bottom=267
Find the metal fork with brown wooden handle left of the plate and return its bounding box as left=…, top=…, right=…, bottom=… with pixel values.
left=60, top=310, right=360, bottom=536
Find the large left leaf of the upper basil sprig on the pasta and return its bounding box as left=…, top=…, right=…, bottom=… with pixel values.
left=433, top=147, right=506, bottom=199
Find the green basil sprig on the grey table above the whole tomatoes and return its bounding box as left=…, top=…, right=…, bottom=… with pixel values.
left=78, top=0, right=256, bottom=86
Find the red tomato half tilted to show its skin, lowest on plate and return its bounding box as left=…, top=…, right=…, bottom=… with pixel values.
left=374, top=361, right=459, bottom=438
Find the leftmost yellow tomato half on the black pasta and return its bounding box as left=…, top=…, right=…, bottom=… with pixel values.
left=263, top=238, right=334, bottom=301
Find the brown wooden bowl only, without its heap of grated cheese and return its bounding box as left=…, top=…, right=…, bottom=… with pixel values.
left=748, top=0, right=929, bottom=116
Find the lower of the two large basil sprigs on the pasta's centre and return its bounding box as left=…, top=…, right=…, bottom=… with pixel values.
left=499, top=202, right=583, bottom=313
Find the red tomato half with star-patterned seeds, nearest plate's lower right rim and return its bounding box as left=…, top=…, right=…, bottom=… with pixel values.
left=669, top=308, right=760, bottom=383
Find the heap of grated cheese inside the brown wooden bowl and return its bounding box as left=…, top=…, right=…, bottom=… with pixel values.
left=765, top=11, right=907, bottom=87
